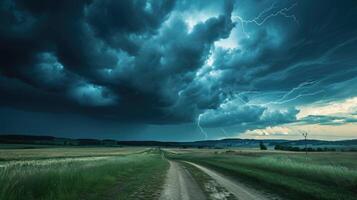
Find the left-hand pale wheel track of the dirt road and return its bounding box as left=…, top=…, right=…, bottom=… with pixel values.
left=160, top=161, right=206, bottom=200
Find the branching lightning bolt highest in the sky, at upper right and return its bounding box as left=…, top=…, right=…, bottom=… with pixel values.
left=232, top=2, right=299, bottom=38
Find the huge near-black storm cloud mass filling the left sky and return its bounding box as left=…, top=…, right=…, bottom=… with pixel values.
left=1, top=1, right=233, bottom=123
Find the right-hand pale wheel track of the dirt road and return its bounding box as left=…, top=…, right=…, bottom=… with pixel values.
left=187, top=162, right=276, bottom=200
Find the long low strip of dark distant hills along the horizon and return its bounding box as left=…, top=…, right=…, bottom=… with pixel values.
left=0, top=135, right=357, bottom=148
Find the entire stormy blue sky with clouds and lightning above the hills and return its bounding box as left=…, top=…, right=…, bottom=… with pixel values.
left=0, top=0, right=357, bottom=141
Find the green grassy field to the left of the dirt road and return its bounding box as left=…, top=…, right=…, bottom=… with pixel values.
left=0, top=148, right=169, bottom=200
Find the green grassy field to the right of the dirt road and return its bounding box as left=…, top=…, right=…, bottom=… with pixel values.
left=166, top=149, right=357, bottom=200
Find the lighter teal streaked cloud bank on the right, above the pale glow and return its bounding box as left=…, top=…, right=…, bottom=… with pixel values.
left=195, top=1, right=357, bottom=131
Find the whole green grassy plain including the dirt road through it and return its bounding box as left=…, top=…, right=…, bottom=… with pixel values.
left=0, top=142, right=357, bottom=200
